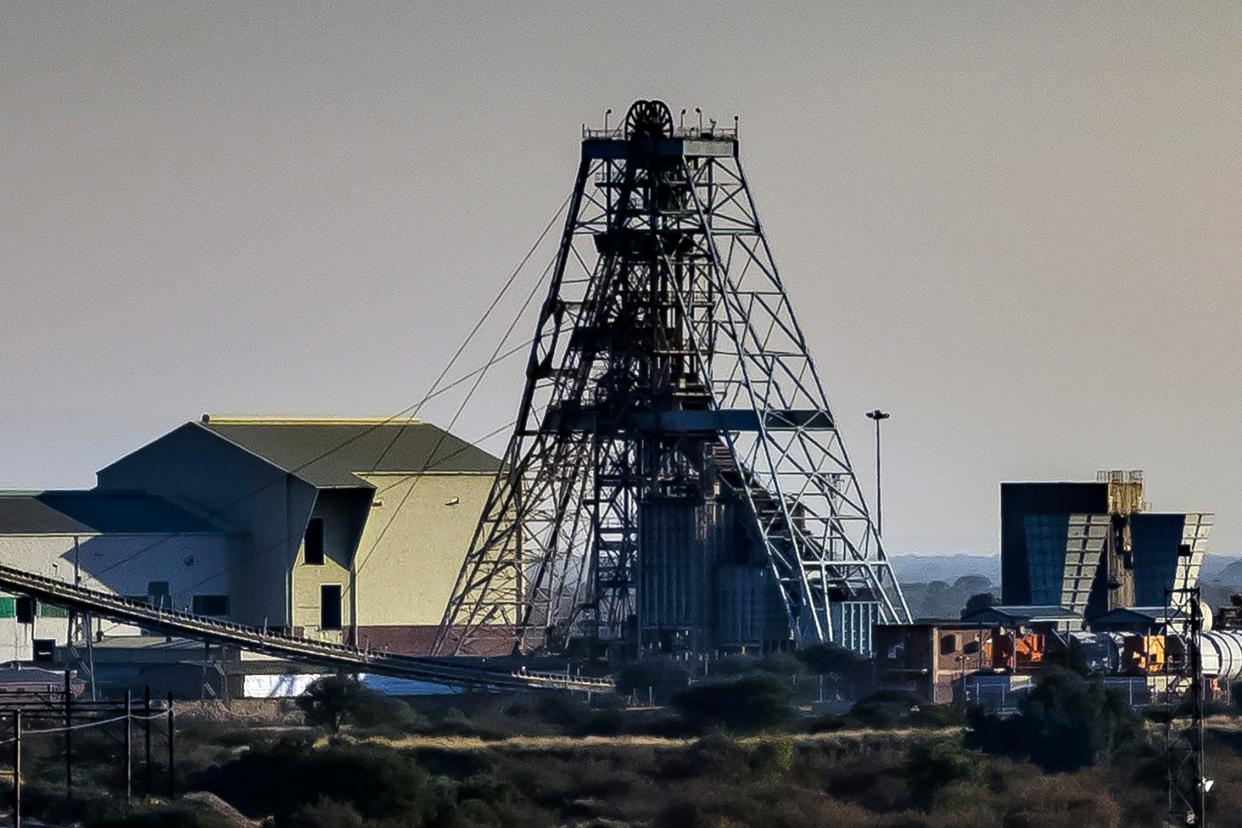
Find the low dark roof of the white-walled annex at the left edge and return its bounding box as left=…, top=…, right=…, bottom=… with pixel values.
left=0, top=489, right=222, bottom=535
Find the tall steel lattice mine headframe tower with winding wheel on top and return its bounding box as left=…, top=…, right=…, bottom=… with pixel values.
left=436, top=101, right=909, bottom=654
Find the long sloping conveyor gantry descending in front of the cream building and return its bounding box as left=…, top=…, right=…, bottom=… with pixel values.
left=0, top=566, right=616, bottom=693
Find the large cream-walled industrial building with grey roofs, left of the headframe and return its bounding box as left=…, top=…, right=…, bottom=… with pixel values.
left=0, top=416, right=498, bottom=660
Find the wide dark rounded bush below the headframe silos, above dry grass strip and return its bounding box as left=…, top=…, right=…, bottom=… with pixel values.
left=673, top=675, right=792, bottom=731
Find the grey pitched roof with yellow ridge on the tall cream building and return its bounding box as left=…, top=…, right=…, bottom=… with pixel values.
left=200, top=415, right=501, bottom=488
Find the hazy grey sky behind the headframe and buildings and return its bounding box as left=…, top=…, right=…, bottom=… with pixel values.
left=0, top=0, right=1242, bottom=552
